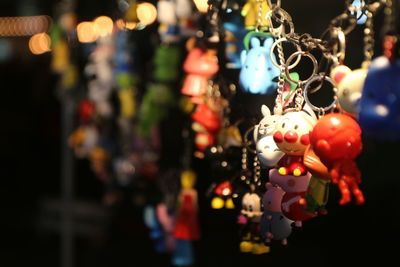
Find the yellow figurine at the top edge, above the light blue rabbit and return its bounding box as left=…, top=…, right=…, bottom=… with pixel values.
left=241, top=0, right=270, bottom=30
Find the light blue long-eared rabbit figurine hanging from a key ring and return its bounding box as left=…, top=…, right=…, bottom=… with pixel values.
left=239, top=32, right=279, bottom=94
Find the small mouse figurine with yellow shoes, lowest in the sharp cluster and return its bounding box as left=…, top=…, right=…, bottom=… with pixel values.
left=238, top=193, right=270, bottom=254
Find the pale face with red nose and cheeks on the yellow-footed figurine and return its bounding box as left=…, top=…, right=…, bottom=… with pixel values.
left=274, top=111, right=316, bottom=156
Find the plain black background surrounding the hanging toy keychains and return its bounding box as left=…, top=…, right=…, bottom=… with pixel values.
left=0, top=0, right=400, bottom=267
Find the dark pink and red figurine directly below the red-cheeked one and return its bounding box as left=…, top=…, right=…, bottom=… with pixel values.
left=269, top=169, right=316, bottom=227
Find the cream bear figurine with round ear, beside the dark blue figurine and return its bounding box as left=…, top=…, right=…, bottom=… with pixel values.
left=331, top=65, right=368, bottom=114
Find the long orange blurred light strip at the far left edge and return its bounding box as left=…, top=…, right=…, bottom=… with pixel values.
left=0, top=16, right=52, bottom=36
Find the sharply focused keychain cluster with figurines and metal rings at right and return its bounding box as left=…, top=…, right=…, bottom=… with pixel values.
left=227, top=0, right=400, bottom=254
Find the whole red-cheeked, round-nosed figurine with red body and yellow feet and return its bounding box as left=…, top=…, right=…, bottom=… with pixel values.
left=273, top=105, right=316, bottom=176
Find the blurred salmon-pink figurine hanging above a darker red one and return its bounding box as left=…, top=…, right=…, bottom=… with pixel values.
left=181, top=48, right=219, bottom=104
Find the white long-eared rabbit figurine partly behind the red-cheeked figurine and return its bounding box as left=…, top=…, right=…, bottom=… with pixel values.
left=254, top=105, right=284, bottom=168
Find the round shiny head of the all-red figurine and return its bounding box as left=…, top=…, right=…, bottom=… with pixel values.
left=310, top=113, right=362, bottom=163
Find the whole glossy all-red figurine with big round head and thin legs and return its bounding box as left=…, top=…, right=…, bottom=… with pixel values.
left=310, top=113, right=364, bottom=205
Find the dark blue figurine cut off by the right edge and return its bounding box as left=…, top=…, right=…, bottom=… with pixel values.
left=358, top=56, right=400, bottom=140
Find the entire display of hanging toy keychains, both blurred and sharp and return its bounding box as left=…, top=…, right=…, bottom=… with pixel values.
left=60, top=0, right=400, bottom=266
